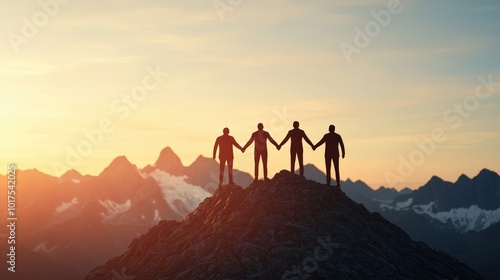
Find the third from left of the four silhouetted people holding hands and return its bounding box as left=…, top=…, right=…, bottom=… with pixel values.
left=278, top=121, right=313, bottom=177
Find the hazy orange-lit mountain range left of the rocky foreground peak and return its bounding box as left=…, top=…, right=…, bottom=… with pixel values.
left=0, top=147, right=253, bottom=279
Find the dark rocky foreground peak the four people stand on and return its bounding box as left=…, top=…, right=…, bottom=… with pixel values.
left=86, top=171, right=481, bottom=280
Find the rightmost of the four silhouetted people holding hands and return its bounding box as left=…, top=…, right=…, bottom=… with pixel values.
left=313, top=124, right=345, bottom=187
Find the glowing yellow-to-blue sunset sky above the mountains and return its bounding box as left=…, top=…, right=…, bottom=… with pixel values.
left=0, top=0, right=500, bottom=188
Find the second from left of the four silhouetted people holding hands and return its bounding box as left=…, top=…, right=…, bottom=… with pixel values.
left=243, top=123, right=278, bottom=181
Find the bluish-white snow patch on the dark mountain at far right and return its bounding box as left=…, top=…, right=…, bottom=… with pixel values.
left=413, top=202, right=500, bottom=232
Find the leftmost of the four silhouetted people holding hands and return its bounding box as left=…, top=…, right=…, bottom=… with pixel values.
left=213, top=127, right=243, bottom=187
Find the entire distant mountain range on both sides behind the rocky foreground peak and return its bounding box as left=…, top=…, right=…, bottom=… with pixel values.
left=0, top=147, right=500, bottom=279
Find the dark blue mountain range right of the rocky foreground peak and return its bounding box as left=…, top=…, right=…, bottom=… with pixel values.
left=305, top=165, right=500, bottom=280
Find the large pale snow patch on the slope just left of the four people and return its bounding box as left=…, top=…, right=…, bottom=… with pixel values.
left=149, top=169, right=212, bottom=216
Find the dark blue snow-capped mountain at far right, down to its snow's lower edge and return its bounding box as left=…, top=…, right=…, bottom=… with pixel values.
left=380, top=169, right=500, bottom=232
